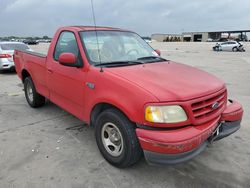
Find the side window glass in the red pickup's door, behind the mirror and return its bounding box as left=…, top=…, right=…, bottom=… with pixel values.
left=54, top=31, right=81, bottom=64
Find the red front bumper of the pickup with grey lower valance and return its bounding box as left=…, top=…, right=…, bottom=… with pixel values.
left=136, top=100, right=243, bottom=164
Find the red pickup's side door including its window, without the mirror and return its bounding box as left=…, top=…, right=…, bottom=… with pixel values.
left=48, top=31, right=85, bottom=118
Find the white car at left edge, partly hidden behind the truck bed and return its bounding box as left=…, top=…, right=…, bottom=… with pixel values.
left=0, top=41, right=33, bottom=71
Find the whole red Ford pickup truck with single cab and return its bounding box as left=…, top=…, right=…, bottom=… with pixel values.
left=14, top=26, right=243, bottom=168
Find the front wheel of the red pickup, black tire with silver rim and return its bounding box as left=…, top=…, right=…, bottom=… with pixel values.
left=95, top=109, right=142, bottom=168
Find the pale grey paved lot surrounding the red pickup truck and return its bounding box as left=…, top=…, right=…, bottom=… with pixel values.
left=0, top=43, right=250, bottom=188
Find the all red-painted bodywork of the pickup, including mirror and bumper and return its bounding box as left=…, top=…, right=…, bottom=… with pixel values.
left=14, top=27, right=243, bottom=157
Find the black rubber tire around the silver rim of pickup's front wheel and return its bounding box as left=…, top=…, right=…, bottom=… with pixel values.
left=95, top=109, right=142, bottom=168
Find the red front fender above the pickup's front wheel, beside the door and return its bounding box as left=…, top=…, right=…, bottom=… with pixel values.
left=84, top=70, right=158, bottom=123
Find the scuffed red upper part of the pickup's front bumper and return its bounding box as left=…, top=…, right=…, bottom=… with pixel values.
left=136, top=101, right=243, bottom=154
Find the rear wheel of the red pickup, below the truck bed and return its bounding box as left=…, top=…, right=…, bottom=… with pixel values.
left=24, top=77, right=45, bottom=108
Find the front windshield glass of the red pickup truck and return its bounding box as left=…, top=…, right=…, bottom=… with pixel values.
left=80, top=31, right=158, bottom=65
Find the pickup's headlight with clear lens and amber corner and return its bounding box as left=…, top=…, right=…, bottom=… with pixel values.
left=145, top=105, right=187, bottom=123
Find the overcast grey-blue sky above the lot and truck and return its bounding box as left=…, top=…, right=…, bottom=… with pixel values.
left=0, top=0, right=250, bottom=36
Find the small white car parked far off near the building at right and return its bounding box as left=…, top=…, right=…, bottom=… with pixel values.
left=213, top=41, right=245, bottom=52
